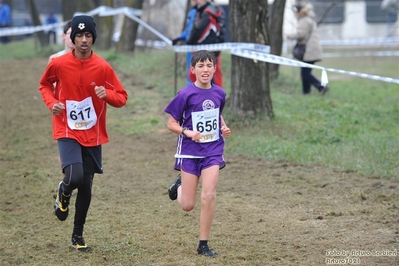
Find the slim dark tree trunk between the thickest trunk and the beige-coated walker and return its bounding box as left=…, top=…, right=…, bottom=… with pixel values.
left=269, top=0, right=286, bottom=78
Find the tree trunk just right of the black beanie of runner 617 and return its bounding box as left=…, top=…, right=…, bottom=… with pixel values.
left=95, top=0, right=114, bottom=50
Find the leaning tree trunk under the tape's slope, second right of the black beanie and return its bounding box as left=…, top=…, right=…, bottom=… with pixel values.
left=116, top=0, right=143, bottom=53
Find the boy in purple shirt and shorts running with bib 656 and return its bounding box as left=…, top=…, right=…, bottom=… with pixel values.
left=165, top=50, right=230, bottom=257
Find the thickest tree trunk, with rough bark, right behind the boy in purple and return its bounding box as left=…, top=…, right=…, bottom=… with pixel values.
left=229, top=0, right=274, bottom=118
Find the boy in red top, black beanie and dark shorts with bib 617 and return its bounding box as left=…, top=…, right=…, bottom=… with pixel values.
left=39, top=16, right=128, bottom=251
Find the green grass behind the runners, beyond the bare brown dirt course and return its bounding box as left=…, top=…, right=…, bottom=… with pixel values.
left=0, top=38, right=399, bottom=176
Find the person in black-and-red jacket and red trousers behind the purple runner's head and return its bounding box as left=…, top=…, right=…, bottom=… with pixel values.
left=187, top=0, right=223, bottom=87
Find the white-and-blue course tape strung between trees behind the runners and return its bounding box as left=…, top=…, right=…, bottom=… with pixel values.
left=0, top=6, right=399, bottom=85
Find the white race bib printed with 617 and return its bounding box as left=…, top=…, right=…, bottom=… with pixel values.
left=66, top=96, right=97, bottom=130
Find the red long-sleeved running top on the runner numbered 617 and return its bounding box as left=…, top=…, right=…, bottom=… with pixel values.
left=39, top=48, right=128, bottom=147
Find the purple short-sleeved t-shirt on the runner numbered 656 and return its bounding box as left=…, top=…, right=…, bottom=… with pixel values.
left=165, top=83, right=226, bottom=157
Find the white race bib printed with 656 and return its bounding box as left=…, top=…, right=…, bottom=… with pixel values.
left=191, top=108, right=220, bottom=143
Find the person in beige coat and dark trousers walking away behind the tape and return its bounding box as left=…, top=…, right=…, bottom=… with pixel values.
left=286, top=3, right=328, bottom=95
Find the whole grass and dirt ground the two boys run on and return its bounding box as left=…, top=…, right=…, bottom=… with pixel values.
left=0, top=40, right=399, bottom=266
